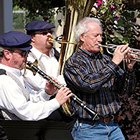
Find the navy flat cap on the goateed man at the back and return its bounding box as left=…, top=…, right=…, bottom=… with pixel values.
left=25, top=20, right=55, bottom=31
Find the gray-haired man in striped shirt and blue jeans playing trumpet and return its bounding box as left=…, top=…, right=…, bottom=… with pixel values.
left=64, top=17, right=135, bottom=140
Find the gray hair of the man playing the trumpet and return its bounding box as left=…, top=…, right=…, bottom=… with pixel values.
left=74, top=17, right=102, bottom=43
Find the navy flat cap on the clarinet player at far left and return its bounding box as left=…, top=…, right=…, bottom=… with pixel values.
left=0, top=31, right=32, bottom=50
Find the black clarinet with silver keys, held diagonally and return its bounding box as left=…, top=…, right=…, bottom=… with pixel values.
left=26, top=61, right=98, bottom=120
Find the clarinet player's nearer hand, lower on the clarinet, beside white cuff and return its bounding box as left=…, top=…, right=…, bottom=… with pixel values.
left=55, top=87, right=72, bottom=105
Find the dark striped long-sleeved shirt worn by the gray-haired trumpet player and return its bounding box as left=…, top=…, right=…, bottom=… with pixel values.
left=63, top=48, right=135, bottom=119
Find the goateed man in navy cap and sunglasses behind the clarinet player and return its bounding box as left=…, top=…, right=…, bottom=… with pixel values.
left=24, top=20, right=73, bottom=120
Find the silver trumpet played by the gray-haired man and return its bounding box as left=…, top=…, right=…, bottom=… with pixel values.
left=99, top=44, right=140, bottom=62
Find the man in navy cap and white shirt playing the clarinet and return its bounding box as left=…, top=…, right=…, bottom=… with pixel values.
left=0, top=31, right=72, bottom=120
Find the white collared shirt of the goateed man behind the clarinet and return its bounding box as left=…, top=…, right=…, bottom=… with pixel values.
left=24, top=47, right=66, bottom=92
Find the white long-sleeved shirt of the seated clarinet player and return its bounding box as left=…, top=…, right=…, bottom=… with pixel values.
left=0, top=64, right=60, bottom=120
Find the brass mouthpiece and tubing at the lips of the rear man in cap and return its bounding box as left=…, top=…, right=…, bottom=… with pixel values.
left=47, top=37, right=77, bottom=45
